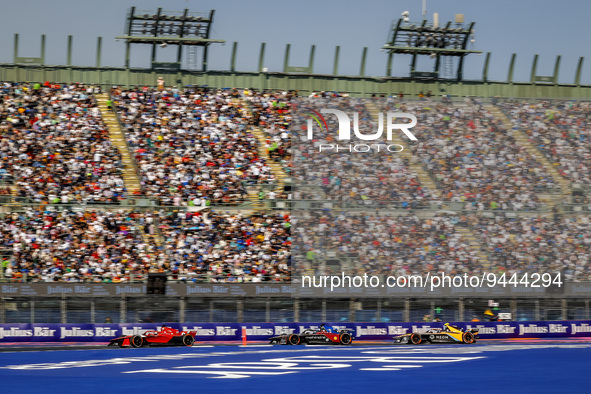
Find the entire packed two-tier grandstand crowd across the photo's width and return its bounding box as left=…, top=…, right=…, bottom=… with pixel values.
left=0, top=82, right=591, bottom=282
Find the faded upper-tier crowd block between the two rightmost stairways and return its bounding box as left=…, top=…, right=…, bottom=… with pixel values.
left=380, top=100, right=555, bottom=210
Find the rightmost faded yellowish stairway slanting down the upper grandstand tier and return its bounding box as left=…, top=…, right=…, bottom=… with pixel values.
left=486, top=105, right=572, bottom=208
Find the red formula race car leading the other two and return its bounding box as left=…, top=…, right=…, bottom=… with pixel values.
left=108, top=326, right=197, bottom=347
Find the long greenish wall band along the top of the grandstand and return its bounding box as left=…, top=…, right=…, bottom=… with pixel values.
left=0, top=64, right=591, bottom=99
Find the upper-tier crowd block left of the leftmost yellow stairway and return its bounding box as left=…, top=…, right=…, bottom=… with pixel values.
left=0, top=82, right=125, bottom=204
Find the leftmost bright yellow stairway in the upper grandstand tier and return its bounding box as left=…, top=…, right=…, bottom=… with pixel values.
left=96, top=93, right=141, bottom=195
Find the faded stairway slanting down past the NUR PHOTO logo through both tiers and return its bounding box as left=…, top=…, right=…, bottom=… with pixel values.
left=365, top=100, right=490, bottom=268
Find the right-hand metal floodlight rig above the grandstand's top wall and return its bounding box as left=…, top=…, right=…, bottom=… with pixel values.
left=382, top=16, right=482, bottom=81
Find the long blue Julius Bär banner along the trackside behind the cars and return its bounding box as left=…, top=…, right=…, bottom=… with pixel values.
left=0, top=320, right=591, bottom=343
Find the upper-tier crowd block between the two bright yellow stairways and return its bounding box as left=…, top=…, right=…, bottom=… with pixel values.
left=114, top=87, right=276, bottom=206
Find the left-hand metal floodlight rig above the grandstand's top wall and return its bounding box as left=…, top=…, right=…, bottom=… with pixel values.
left=115, top=7, right=226, bottom=71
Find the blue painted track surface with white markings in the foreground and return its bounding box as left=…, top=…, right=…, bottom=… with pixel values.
left=0, top=342, right=591, bottom=394
